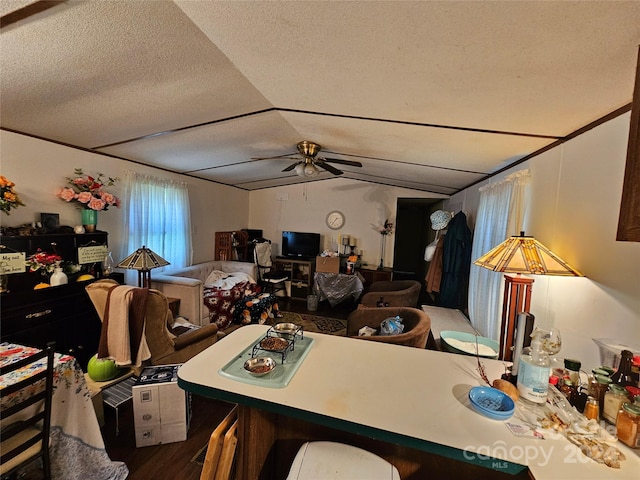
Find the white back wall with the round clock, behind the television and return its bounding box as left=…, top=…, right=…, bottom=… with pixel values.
left=249, top=178, right=446, bottom=267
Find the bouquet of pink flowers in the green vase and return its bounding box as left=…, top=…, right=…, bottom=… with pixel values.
left=58, top=168, right=120, bottom=211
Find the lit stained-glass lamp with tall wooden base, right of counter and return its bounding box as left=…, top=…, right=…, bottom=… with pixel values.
left=473, top=232, right=582, bottom=361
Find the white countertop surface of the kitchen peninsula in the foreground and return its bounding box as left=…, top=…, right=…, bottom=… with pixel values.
left=178, top=325, right=640, bottom=480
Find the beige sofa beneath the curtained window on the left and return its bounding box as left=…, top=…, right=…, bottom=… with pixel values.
left=151, top=260, right=257, bottom=325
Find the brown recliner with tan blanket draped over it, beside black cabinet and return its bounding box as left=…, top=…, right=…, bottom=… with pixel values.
left=85, top=280, right=218, bottom=365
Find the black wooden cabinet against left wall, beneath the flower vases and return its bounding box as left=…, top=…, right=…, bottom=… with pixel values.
left=0, top=232, right=117, bottom=371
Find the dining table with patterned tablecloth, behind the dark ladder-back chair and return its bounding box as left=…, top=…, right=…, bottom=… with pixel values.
left=0, top=342, right=129, bottom=480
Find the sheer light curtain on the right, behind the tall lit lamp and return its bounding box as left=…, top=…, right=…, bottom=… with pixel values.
left=469, top=170, right=530, bottom=340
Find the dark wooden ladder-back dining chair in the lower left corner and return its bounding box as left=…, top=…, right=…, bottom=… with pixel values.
left=0, top=342, right=55, bottom=480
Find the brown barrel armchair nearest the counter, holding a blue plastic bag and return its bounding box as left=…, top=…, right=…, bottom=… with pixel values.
left=347, top=307, right=431, bottom=348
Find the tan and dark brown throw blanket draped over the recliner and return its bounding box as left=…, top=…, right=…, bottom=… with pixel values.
left=98, top=285, right=151, bottom=367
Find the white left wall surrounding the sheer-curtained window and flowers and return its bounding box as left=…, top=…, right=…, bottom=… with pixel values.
left=0, top=131, right=249, bottom=268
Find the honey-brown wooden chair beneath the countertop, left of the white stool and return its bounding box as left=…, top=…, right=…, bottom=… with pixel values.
left=200, top=405, right=238, bottom=480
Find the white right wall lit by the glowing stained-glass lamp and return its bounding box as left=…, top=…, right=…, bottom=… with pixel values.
left=450, top=114, right=640, bottom=369
